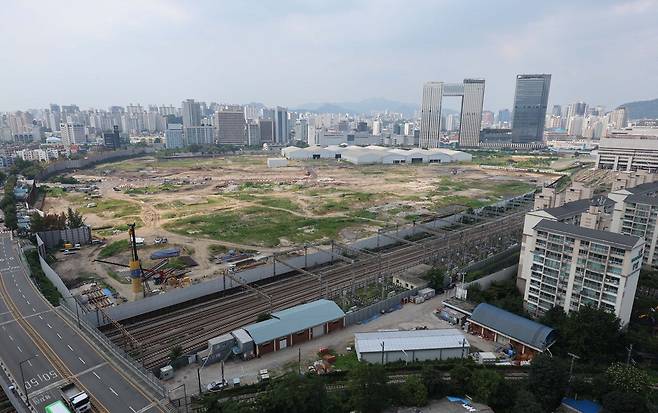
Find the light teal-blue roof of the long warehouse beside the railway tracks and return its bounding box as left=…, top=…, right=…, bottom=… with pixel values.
left=244, top=300, right=345, bottom=344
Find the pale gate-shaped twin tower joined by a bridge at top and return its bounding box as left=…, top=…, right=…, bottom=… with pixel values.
left=418, top=79, right=484, bottom=148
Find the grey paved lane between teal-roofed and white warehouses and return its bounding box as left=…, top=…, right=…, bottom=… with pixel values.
left=163, top=290, right=494, bottom=394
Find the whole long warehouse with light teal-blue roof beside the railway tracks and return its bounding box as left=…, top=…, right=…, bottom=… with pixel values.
left=244, top=300, right=345, bottom=357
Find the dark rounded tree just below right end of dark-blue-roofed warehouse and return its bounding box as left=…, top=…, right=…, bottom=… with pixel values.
left=528, top=354, right=569, bottom=411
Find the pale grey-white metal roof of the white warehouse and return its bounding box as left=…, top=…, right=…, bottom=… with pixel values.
left=354, top=328, right=470, bottom=353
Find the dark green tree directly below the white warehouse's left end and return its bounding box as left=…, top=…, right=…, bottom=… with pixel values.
left=348, top=363, right=389, bottom=413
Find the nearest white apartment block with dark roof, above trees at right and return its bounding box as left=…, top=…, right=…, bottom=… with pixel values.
left=522, top=219, right=644, bottom=325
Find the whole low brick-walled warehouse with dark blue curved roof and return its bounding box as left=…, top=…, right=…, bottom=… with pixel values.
left=468, top=303, right=557, bottom=360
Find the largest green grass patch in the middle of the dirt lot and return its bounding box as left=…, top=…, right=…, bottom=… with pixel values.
left=165, top=207, right=360, bottom=247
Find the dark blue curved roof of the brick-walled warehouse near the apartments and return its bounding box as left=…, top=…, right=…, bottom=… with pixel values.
left=471, top=303, right=556, bottom=351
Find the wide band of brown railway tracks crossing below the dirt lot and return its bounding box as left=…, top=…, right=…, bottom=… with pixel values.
left=105, top=203, right=527, bottom=368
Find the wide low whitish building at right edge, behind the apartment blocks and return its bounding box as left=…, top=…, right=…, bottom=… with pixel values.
left=596, top=131, right=658, bottom=172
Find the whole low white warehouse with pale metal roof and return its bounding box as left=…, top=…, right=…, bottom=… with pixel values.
left=354, top=328, right=470, bottom=364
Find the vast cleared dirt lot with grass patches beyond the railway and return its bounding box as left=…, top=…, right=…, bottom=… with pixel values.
left=44, top=155, right=558, bottom=303
